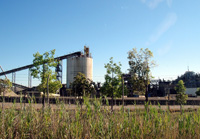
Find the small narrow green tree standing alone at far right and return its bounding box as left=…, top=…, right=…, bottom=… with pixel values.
left=175, top=80, right=188, bottom=113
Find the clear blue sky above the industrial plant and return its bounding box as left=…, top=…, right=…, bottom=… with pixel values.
left=0, top=0, right=200, bottom=85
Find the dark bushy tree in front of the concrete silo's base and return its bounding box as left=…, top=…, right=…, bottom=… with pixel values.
left=70, top=72, right=94, bottom=96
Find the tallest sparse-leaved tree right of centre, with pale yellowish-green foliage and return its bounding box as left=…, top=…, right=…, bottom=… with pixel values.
left=128, top=48, right=155, bottom=99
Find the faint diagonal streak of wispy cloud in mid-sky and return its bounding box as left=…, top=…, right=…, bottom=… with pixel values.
left=146, top=13, right=177, bottom=45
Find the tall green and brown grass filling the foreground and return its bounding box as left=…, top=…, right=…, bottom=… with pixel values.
left=0, top=98, right=200, bottom=139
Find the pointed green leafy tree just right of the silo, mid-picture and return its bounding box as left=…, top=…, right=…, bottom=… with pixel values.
left=101, top=57, right=122, bottom=97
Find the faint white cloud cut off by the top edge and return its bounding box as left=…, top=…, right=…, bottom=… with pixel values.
left=140, top=0, right=172, bottom=9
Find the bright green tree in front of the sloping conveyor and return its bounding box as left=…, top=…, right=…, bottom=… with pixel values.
left=31, top=49, right=62, bottom=105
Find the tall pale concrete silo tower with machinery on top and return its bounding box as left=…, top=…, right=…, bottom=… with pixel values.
left=67, top=46, right=93, bottom=88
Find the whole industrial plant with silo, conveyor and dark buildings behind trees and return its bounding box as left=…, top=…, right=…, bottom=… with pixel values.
left=0, top=46, right=200, bottom=100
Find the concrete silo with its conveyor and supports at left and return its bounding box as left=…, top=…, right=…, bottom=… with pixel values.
left=0, top=46, right=93, bottom=96
